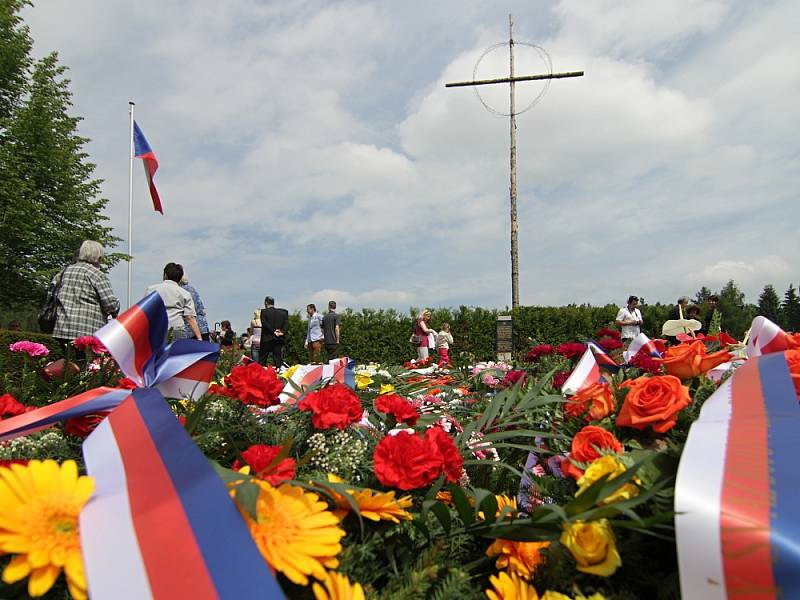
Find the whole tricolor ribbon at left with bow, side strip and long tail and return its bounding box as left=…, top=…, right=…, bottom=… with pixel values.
left=0, top=293, right=283, bottom=600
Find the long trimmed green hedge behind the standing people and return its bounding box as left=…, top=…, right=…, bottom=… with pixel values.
left=0, top=304, right=670, bottom=372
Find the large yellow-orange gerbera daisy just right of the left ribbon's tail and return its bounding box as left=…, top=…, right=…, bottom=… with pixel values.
left=242, top=479, right=345, bottom=585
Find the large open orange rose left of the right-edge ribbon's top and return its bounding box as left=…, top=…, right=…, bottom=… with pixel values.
left=617, top=375, right=691, bottom=433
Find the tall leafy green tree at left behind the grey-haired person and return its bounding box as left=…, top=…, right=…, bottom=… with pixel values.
left=0, top=0, right=121, bottom=308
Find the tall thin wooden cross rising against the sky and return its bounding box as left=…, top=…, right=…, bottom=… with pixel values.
left=445, top=15, right=583, bottom=308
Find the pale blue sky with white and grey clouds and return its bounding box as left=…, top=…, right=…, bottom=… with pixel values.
left=25, top=0, right=800, bottom=327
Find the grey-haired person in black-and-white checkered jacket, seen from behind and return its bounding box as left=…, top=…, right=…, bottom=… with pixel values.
left=47, top=240, right=119, bottom=350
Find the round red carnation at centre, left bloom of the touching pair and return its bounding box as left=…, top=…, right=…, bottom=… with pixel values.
left=372, top=431, right=447, bottom=490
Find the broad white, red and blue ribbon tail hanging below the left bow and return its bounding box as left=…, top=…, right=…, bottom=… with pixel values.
left=80, top=389, right=283, bottom=600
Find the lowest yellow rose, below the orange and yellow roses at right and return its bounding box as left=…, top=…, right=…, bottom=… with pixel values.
left=560, top=519, right=622, bottom=577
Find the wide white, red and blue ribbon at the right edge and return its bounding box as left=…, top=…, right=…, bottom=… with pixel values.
left=675, top=352, right=800, bottom=600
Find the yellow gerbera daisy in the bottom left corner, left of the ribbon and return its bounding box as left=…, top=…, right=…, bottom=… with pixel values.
left=0, top=460, right=94, bottom=600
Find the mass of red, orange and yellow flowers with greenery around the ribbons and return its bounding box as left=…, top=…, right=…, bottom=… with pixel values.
left=0, top=330, right=800, bottom=600
